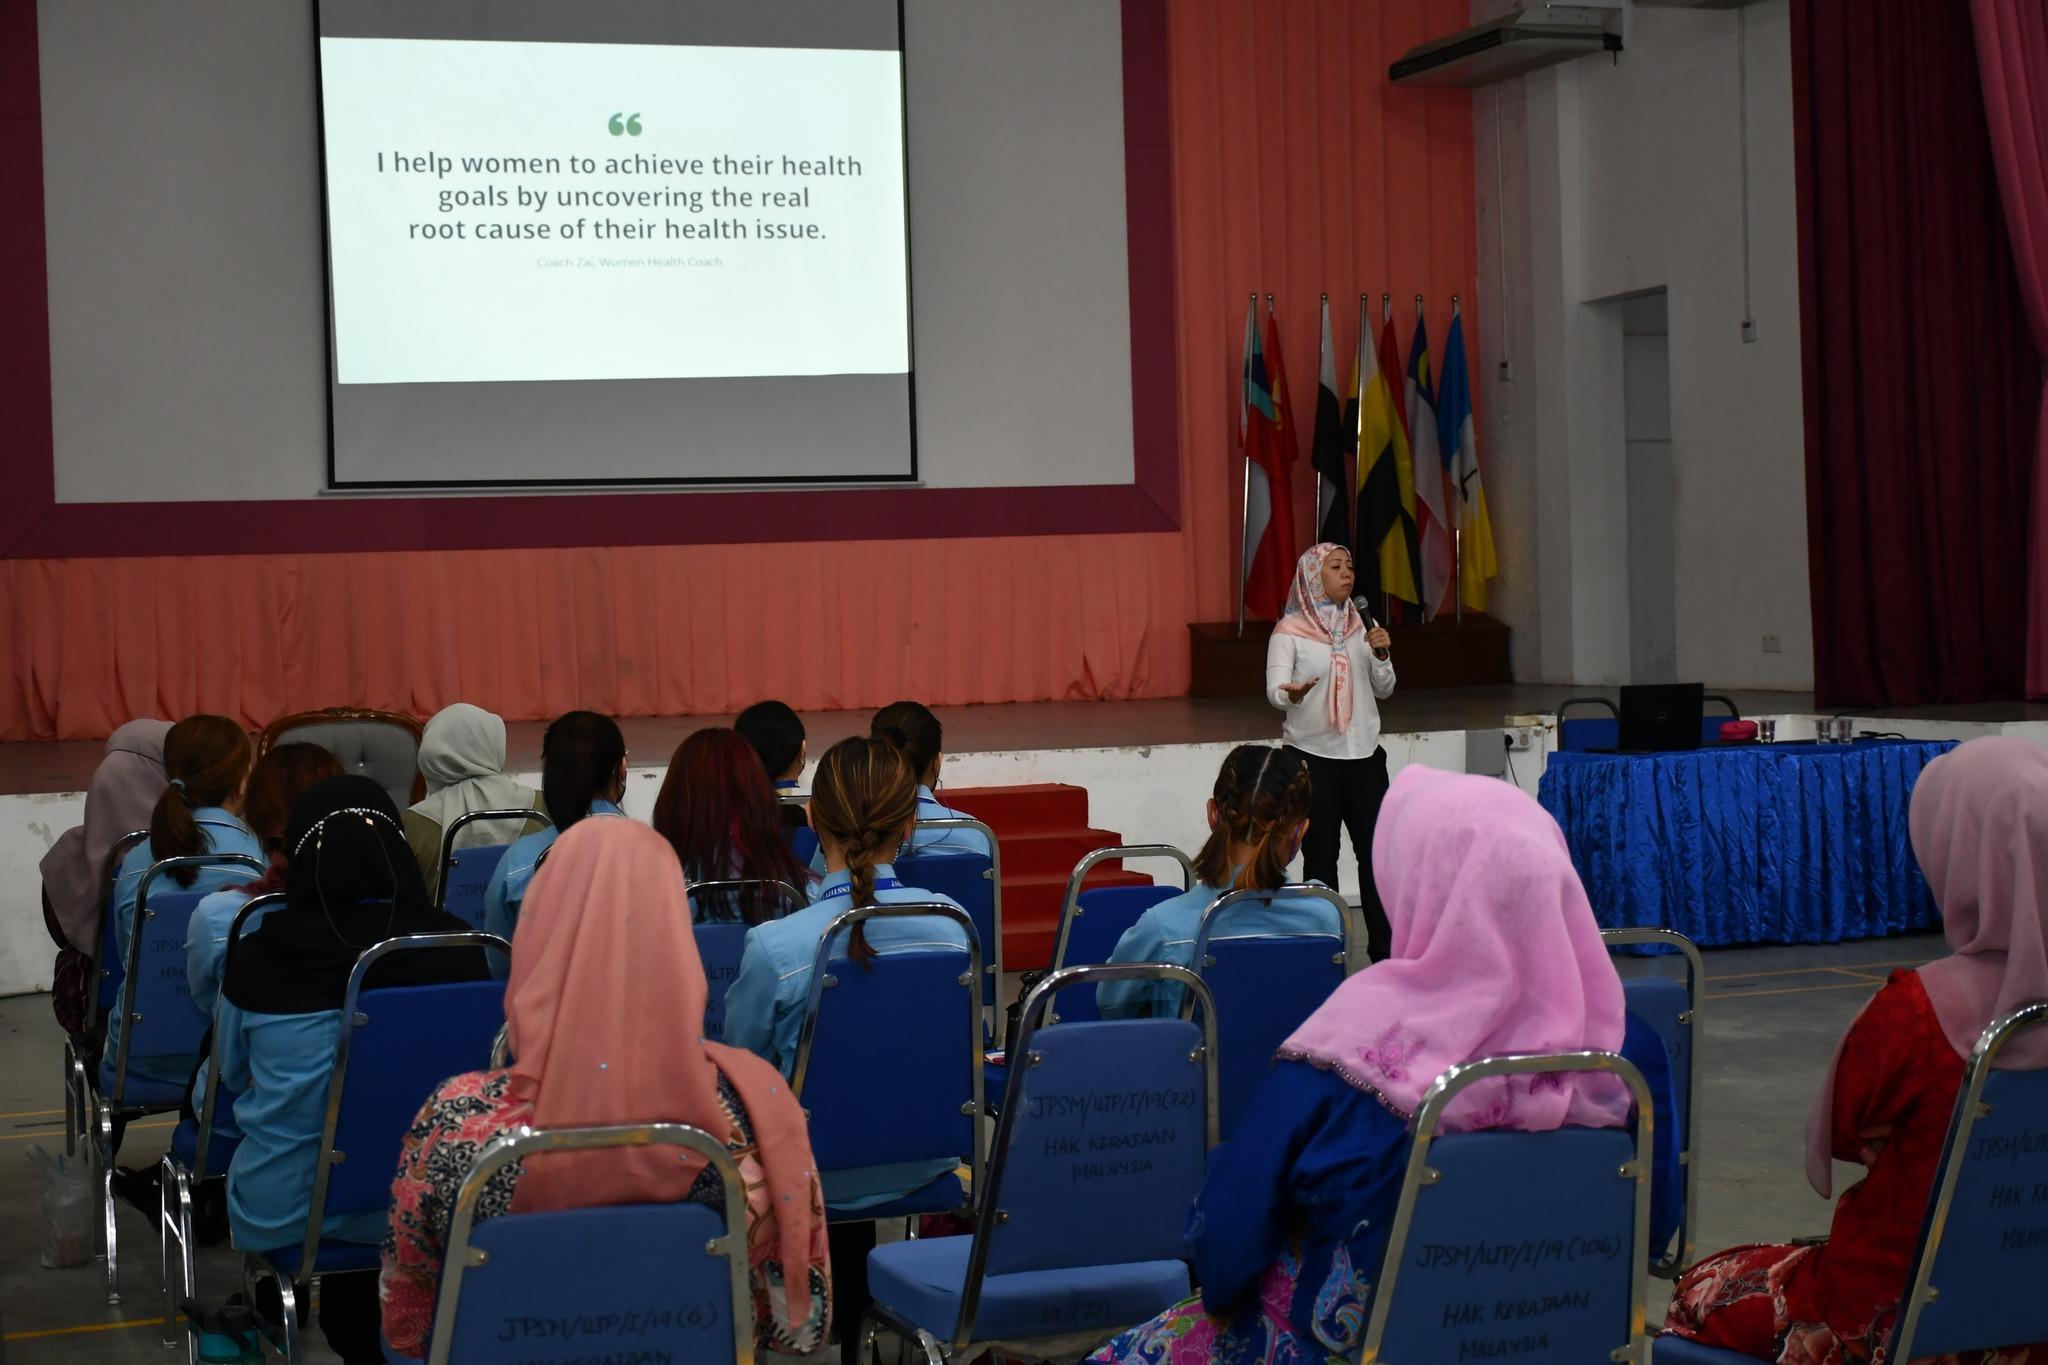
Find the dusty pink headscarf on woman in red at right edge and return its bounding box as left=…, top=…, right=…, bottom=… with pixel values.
left=1806, top=739, right=2048, bottom=1197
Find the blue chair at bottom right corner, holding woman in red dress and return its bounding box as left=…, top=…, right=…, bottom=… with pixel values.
left=1651, top=1003, right=2048, bottom=1365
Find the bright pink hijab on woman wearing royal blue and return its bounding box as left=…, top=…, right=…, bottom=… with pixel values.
left=1280, top=765, right=1628, bottom=1132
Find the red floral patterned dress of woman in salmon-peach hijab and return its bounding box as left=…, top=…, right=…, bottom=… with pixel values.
left=379, top=1070, right=831, bottom=1357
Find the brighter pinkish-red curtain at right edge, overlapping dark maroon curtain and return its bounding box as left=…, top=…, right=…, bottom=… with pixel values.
left=1970, top=0, right=2048, bottom=696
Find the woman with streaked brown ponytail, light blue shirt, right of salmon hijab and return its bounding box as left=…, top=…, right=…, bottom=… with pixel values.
left=725, top=739, right=967, bottom=1361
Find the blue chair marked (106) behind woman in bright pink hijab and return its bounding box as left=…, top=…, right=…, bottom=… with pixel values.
left=1358, top=1052, right=1654, bottom=1365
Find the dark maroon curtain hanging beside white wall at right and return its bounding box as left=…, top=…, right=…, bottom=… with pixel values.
left=1792, top=0, right=2042, bottom=708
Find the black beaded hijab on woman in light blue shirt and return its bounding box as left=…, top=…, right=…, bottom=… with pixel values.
left=221, top=776, right=487, bottom=1015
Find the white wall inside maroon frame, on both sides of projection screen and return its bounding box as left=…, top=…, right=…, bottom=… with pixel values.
left=37, top=0, right=1133, bottom=501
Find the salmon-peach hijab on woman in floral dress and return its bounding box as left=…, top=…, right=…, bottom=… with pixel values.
left=506, top=821, right=825, bottom=1322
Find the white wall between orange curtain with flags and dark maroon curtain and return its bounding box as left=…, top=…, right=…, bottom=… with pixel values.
left=1473, top=0, right=1812, bottom=690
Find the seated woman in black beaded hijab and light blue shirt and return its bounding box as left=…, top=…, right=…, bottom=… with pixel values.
left=217, top=778, right=483, bottom=1365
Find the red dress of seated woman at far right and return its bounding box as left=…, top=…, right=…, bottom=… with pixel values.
left=1665, top=972, right=2048, bottom=1365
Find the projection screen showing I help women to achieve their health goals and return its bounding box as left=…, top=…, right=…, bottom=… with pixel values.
left=319, top=0, right=915, bottom=485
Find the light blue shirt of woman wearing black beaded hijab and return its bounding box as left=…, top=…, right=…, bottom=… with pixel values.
left=219, top=999, right=389, bottom=1250
